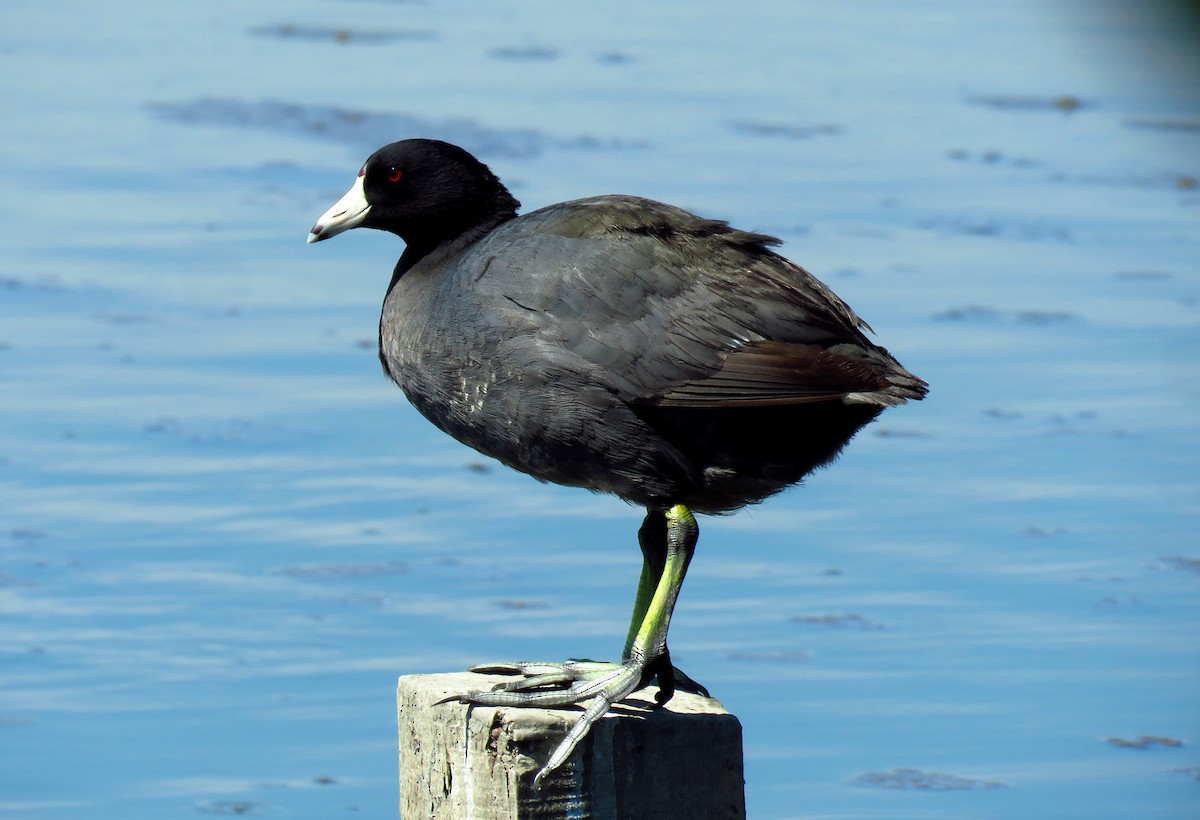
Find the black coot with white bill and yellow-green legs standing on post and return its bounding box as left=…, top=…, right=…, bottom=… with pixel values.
left=308, top=139, right=926, bottom=783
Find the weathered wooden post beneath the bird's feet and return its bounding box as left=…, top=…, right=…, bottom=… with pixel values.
left=396, top=672, right=745, bottom=820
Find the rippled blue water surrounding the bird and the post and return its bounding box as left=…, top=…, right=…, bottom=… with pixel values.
left=0, top=0, right=1200, bottom=820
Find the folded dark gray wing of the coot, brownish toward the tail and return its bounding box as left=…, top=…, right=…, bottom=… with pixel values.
left=463, top=197, right=924, bottom=407
